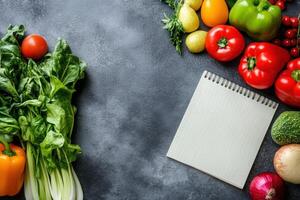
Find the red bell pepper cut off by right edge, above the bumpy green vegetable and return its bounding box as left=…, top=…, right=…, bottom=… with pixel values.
left=275, top=58, right=300, bottom=108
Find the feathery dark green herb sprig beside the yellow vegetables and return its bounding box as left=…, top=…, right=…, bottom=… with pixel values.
left=162, top=0, right=184, bottom=54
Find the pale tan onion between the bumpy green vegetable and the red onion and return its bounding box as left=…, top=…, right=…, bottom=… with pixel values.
left=273, top=144, right=300, bottom=184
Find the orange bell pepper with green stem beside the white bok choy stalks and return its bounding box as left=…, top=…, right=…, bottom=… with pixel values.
left=0, top=137, right=26, bottom=196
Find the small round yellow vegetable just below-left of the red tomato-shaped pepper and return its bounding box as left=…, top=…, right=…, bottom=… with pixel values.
left=185, top=31, right=207, bottom=53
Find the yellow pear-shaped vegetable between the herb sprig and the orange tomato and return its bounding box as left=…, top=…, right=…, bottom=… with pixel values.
left=178, top=4, right=200, bottom=33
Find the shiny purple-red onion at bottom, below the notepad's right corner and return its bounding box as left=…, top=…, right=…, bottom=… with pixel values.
left=250, top=172, right=284, bottom=200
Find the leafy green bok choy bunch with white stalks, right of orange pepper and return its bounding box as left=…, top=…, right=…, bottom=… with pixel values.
left=19, top=40, right=86, bottom=200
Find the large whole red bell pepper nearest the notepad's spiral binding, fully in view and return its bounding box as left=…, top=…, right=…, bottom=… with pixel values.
left=239, top=42, right=290, bottom=89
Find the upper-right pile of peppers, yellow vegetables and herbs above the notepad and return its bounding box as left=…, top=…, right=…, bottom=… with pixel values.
left=162, top=0, right=300, bottom=107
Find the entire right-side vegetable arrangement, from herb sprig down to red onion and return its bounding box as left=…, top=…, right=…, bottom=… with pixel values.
left=162, top=0, right=300, bottom=200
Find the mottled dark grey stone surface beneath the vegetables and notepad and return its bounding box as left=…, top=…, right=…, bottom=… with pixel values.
left=0, top=0, right=300, bottom=200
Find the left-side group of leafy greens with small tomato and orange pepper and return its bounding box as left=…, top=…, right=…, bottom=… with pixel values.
left=0, top=25, right=86, bottom=200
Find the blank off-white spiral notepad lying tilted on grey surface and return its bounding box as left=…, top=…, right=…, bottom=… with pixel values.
left=167, top=71, right=278, bottom=189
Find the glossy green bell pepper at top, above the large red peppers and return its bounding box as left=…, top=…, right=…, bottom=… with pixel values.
left=229, top=0, right=281, bottom=41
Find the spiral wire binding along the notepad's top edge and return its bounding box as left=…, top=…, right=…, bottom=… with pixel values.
left=203, top=71, right=278, bottom=109
